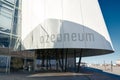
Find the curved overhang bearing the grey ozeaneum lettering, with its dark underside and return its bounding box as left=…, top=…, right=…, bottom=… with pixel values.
left=22, top=19, right=114, bottom=57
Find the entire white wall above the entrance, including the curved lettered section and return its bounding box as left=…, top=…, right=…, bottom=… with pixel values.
left=22, top=0, right=113, bottom=55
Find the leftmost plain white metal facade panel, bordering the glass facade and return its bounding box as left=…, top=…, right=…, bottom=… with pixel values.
left=22, top=0, right=45, bottom=40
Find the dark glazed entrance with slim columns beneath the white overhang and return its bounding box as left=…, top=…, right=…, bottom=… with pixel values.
left=35, top=49, right=82, bottom=72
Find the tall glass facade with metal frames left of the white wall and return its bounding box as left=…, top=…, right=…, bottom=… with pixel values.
left=0, top=0, right=21, bottom=50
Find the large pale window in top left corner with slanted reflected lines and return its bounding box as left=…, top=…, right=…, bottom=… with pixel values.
left=0, top=0, right=14, bottom=33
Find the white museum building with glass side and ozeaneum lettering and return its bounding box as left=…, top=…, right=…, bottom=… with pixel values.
left=0, top=0, right=114, bottom=72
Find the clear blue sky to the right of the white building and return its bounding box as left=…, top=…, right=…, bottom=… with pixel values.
left=82, top=0, right=120, bottom=63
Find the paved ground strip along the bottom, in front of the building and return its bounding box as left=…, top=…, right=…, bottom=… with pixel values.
left=0, top=72, right=120, bottom=80
